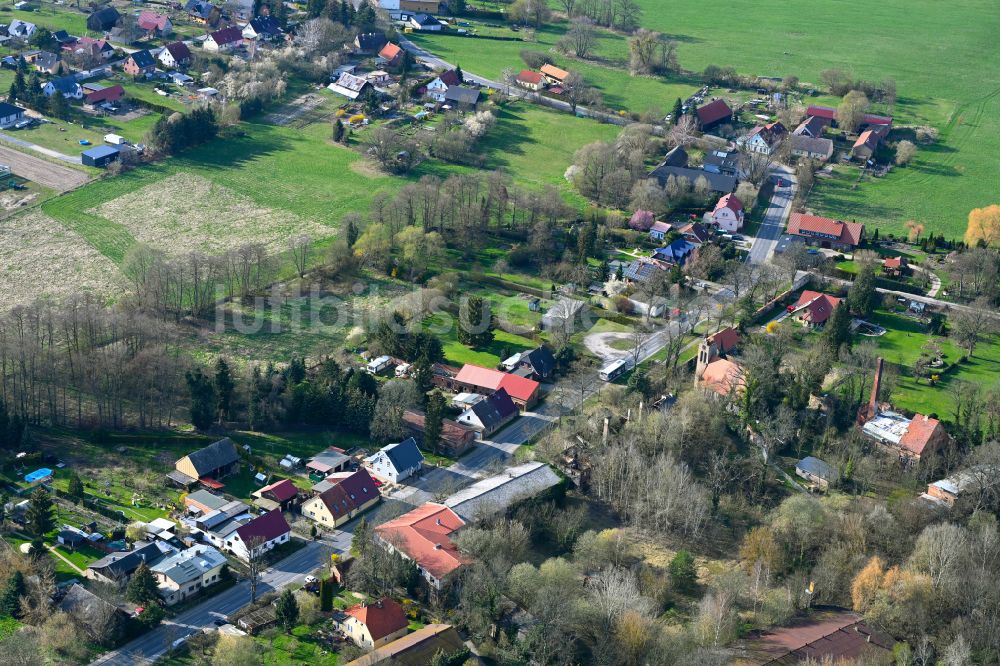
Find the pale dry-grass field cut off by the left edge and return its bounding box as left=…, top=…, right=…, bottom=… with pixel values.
left=0, top=210, right=122, bottom=307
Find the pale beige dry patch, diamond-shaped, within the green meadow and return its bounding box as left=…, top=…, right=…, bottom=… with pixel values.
left=88, top=173, right=334, bottom=255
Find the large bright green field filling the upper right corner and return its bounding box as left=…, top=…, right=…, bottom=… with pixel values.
left=628, top=0, right=1000, bottom=237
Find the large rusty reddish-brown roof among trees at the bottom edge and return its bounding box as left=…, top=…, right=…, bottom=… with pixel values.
left=732, top=610, right=895, bottom=666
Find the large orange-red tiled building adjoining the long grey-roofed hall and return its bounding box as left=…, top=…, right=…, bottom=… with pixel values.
left=375, top=502, right=468, bottom=590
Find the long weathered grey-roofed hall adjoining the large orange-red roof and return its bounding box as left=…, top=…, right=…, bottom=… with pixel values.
left=444, top=462, right=562, bottom=523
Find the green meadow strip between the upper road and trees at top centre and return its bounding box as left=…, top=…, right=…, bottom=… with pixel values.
left=407, top=20, right=695, bottom=116
